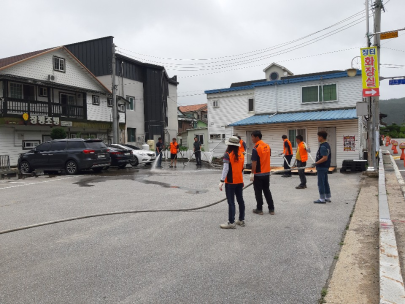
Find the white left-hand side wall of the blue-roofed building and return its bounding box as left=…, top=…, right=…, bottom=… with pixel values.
left=207, top=90, right=254, bottom=156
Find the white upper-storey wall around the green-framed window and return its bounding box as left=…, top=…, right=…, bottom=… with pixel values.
left=254, top=76, right=362, bottom=114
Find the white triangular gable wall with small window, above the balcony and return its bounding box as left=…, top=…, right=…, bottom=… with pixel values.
left=0, top=50, right=103, bottom=91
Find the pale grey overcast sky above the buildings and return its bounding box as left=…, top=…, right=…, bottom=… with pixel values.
left=0, top=0, right=405, bottom=105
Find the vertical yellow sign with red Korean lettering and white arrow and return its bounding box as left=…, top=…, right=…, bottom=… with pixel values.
left=360, top=46, right=380, bottom=97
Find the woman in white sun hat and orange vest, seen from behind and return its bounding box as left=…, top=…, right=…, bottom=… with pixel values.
left=219, top=136, right=245, bottom=229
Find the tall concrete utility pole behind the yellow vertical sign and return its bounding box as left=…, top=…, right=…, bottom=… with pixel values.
left=373, top=0, right=383, bottom=169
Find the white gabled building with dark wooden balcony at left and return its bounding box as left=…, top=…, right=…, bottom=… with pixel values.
left=0, top=47, right=125, bottom=166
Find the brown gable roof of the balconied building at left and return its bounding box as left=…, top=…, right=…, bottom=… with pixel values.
left=0, top=46, right=112, bottom=94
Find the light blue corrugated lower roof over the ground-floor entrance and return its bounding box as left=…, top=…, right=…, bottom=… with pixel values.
left=230, top=109, right=357, bottom=127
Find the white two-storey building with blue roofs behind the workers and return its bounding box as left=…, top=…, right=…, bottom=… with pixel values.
left=205, top=64, right=363, bottom=167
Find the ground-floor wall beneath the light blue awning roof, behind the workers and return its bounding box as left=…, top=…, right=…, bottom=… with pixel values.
left=232, top=119, right=362, bottom=168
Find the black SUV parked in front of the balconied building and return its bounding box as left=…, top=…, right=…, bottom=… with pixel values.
left=18, top=138, right=111, bottom=174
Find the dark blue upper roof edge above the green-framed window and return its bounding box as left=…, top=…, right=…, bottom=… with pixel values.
left=204, top=70, right=361, bottom=94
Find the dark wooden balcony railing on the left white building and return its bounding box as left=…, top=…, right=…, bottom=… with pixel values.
left=0, top=98, right=86, bottom=119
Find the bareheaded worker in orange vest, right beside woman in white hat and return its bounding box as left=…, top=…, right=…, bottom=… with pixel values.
left=250, top=131, right=274, bottom=215
